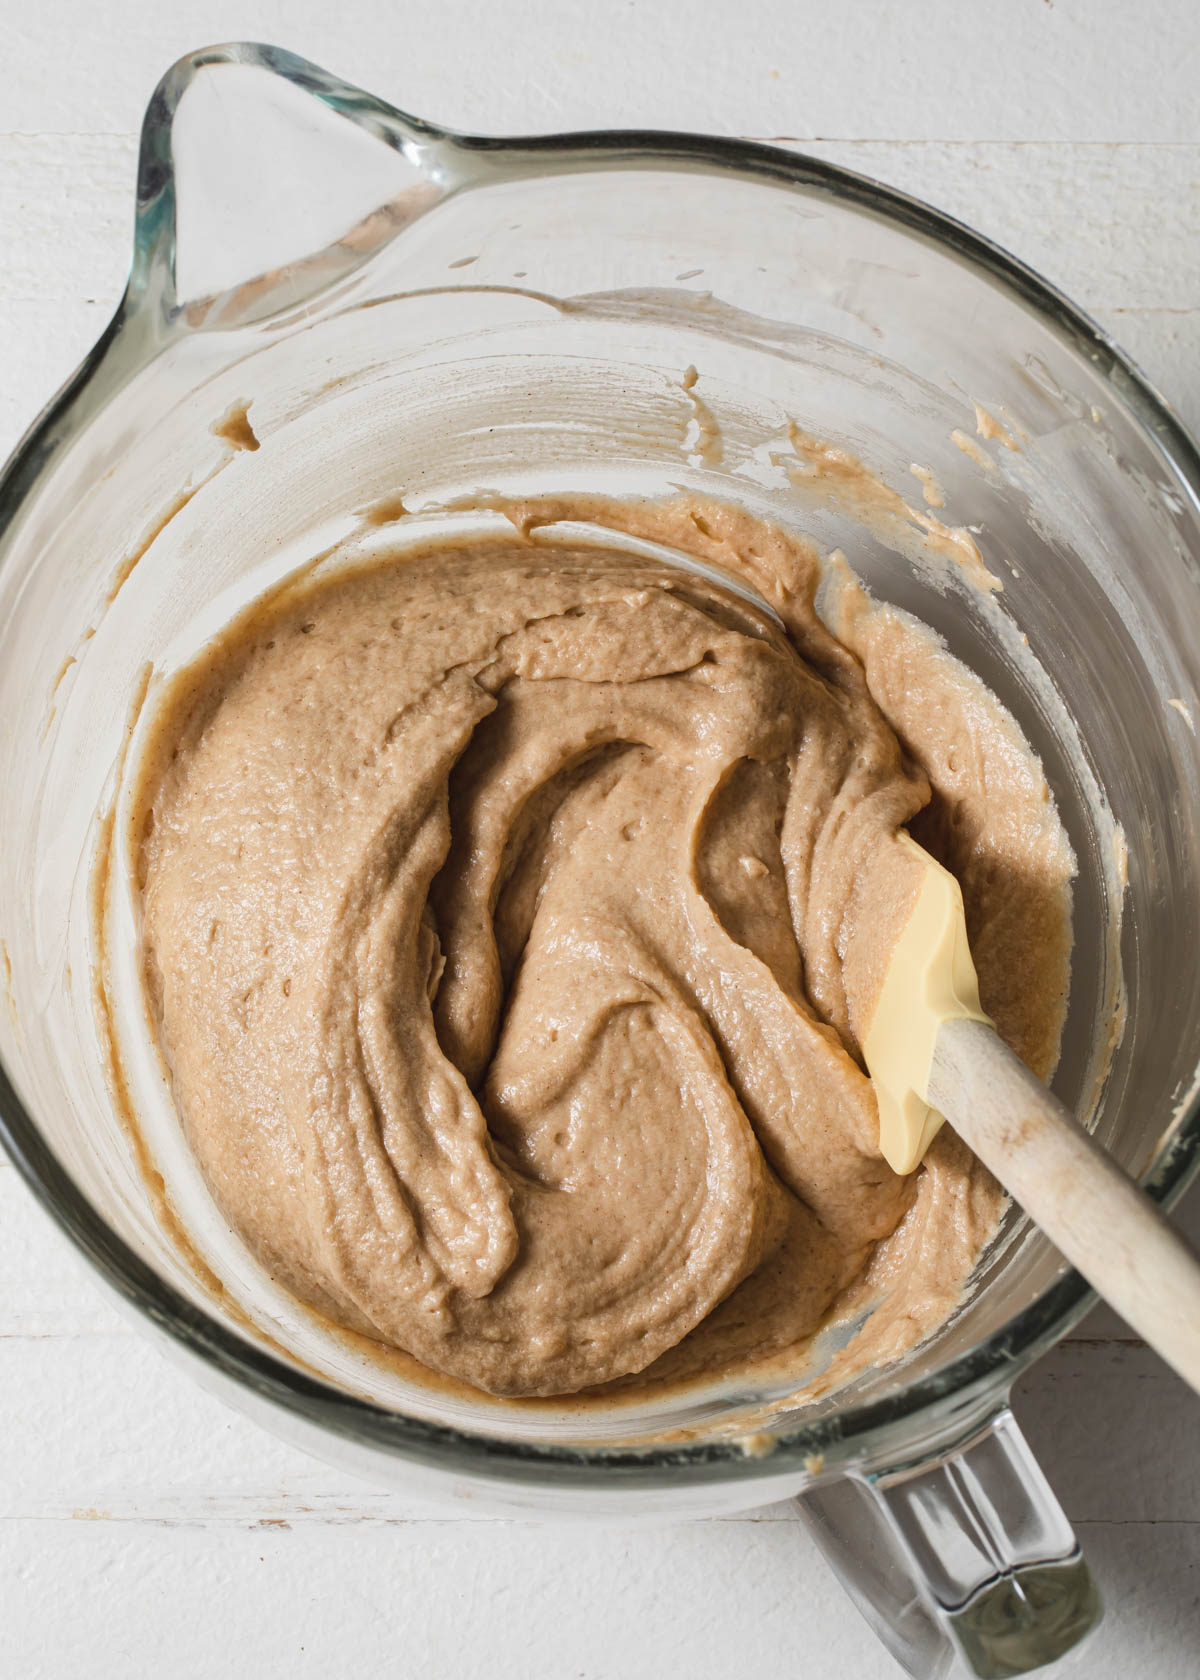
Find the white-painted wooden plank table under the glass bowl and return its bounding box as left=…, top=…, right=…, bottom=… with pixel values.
left=0, top=0, right=1200, bottom=1680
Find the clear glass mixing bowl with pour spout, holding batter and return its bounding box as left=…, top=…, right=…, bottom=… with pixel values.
left=0, top=45, right=1200, bottom=1675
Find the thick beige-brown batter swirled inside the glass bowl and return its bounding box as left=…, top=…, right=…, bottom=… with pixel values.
left=136, top=501, right=1072, bottom=1396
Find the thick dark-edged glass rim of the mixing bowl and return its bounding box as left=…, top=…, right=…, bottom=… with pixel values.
left=0, top=47, right=1200, bottom=1492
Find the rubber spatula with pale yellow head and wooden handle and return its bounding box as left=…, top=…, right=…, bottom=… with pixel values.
left=859, top=833, right=1200, bottom=1389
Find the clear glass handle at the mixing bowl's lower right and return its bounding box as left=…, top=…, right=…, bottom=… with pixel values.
left=797, top=1408, right=1103, bottom=1680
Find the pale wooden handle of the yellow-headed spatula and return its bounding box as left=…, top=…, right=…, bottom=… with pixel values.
left=929, top=1021, right=1200, bottom=1391
